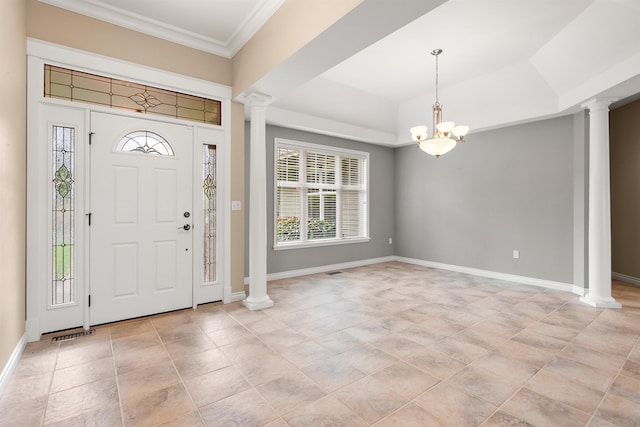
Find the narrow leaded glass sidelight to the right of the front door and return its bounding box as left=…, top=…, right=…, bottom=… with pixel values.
left=202, top=145, right=216, bottom=283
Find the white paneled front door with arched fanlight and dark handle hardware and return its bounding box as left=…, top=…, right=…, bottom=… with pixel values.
left=89, top=112, right=193, bottom=325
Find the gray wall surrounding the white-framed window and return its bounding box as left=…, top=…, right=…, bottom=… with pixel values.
left=245, top=123, right=395, bottom=276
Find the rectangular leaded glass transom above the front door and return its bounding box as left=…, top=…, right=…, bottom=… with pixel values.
left=44, top=64, right=222, bottom=126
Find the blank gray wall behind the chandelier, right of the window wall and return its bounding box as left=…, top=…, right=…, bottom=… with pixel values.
left=396, top=116, right=575, bottom=283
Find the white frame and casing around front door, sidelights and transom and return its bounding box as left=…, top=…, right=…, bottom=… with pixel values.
left=25, top=38, right=232, bottom=341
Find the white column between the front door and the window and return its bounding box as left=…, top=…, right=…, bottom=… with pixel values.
left=242, top=93, right=273, bottom=310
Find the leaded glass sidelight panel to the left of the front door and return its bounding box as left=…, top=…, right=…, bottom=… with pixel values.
left=51, top=126, right=75, bottom=306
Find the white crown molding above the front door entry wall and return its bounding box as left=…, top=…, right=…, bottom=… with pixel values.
left=38, top=0, right=285, bottom=58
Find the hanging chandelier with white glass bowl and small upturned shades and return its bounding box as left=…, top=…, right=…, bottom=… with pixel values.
left=411, top=49, right=469, bottom=157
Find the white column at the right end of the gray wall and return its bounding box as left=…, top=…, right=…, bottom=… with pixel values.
left=580, top=98, right=621, bottom=308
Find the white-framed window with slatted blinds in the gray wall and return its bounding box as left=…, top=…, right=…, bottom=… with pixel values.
left=274, top=138, right=369, bottom=249
